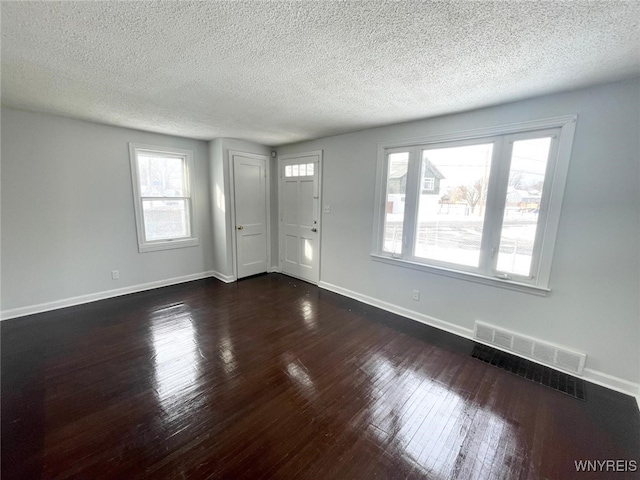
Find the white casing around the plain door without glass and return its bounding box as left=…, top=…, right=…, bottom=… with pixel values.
left=228, top=150, right=271, bottom=282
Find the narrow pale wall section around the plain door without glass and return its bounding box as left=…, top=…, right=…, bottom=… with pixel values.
left=209, top=138, right=277, bottom=281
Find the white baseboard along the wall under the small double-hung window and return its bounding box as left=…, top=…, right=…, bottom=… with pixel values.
left=0, top=271, right=215, bottom=321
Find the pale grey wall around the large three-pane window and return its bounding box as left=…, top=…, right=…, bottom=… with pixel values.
left=278, top=79, right=640, bottom=383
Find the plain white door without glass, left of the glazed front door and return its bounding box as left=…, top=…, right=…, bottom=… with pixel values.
left=229, top=152, right=269, bottom=279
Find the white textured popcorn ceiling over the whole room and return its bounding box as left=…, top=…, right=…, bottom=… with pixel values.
left=1, top=1, right=640, bottom=145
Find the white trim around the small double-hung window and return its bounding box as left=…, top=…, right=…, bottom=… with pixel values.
left=129, top=143, right=199, bottom=253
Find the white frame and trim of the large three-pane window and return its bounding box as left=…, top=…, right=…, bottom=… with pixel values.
left=371, top=115, right=578, bottom=295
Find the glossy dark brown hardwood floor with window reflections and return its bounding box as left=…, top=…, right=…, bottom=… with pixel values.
left=1, top=275, right=640, bottom=479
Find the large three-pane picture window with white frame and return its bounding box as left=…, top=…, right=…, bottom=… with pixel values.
left=372, top=116, right=576, bottom=293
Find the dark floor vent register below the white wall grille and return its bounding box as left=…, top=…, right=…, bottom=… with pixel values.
left=471, top=345, right=586, bottom=401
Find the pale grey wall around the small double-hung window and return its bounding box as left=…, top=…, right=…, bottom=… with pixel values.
left=1, top=108, right=213, bottom=312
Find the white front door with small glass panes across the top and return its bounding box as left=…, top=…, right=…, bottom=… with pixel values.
left=279, top=151, right=322, bottom=283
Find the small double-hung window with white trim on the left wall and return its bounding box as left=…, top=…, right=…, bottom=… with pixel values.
left=129, top=143, right=198, bottom=253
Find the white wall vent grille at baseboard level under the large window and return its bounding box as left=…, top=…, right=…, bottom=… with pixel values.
left=473, top=321, right=587, bottom=375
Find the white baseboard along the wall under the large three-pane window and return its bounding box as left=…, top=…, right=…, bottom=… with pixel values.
left=318, top=282, right=640, bottom=400
